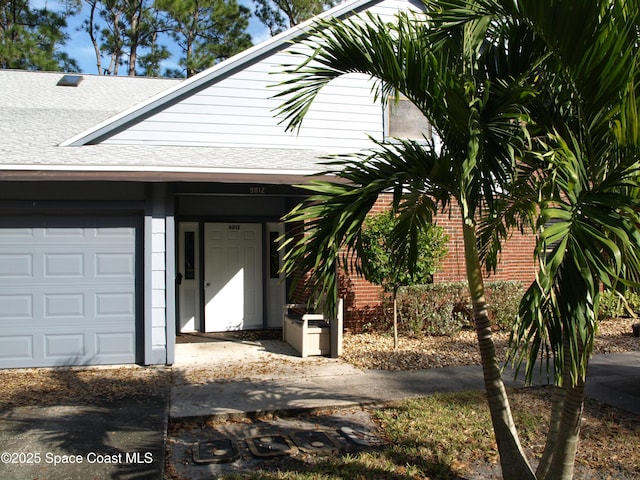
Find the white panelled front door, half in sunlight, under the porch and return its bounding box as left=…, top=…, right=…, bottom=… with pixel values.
left=204, top=223, right=263, bottom=332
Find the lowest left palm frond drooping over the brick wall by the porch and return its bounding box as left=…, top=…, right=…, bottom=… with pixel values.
left=283, top=141, right=451, bottom=316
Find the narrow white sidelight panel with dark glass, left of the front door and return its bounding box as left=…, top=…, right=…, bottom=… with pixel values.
left=177, top=222, right=200, bottom=332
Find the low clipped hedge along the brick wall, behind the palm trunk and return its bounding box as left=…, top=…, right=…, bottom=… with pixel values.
left=385, top=282, right=524, bottom=336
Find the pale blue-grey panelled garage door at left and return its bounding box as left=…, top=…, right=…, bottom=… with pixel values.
left=0, top=217, right=139, bottom=368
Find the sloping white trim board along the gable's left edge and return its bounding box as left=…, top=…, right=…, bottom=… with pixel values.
left=62, top=0, right=410, bottom=145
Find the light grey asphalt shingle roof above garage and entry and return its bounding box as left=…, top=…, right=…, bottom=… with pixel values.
left=0, top=70, right=336, bottom=181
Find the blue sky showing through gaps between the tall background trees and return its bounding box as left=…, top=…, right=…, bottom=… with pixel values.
left=29, top=0, right=269, bottom=74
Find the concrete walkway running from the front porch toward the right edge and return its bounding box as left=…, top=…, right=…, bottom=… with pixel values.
left=170, top=340, right=640, bottom=419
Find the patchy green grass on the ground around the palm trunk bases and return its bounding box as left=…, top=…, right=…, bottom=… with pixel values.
left=224, top=388, right=640, bottom=480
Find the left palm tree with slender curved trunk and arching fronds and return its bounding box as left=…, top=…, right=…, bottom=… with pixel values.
left=278, top=5, right=535, bottom=479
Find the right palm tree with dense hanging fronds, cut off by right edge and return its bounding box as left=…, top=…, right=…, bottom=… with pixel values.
left=456, top=0, right=640, bottom=479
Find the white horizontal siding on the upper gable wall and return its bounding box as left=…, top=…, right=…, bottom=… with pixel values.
left=104, top=1, right=420, bottom=153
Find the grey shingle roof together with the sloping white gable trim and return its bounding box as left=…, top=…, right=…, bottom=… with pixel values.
left=0, top=0, right=419, bottom=184
